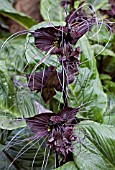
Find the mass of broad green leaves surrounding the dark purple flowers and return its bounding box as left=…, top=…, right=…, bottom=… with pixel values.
left=0, top=0, right=115, bottom=170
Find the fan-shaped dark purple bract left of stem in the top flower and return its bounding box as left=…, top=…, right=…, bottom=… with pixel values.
left=32, top=27, right=62, bottom=54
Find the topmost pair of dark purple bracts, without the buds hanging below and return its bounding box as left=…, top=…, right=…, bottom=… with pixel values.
left=32, top=7, right=95, bottom=55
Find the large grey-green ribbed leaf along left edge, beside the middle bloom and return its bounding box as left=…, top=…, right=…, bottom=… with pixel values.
left=0, top=38, right=37, bottom=130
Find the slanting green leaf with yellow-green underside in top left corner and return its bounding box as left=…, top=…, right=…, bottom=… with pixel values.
left=0, top=0, right=36, bottom=29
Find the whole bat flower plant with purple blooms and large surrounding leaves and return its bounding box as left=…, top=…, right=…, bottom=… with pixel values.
left=1, top=1, right=115, bottom=170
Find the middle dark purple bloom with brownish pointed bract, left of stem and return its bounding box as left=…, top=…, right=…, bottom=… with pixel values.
left=26, top=66, right=73, bottom=102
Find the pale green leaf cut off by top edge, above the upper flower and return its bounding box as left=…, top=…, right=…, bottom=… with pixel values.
left=40, top=0, right=64, bottom=21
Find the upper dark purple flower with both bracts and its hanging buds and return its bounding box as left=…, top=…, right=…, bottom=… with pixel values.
left=32, top=6, right=95, bottom=86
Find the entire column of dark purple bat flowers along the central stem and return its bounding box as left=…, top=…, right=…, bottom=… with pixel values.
left=25, top=1, right=95, bottom=166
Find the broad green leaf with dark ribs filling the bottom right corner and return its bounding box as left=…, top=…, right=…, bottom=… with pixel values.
left=73, top=121, right=115, bottom=170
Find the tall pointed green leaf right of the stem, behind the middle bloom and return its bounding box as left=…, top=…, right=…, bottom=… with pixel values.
left=70, top=36, right=107, bottom=122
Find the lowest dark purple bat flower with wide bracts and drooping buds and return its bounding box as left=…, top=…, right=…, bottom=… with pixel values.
left=25, top=107, right=79, bottom=160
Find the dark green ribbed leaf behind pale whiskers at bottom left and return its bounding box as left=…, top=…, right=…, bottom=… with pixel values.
left=0, top=129, right=54, bottom=170
